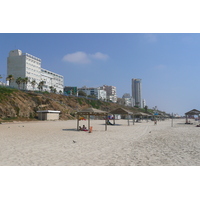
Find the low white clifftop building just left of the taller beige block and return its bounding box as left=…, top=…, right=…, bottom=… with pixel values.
left=78, top=87, right=107, bottom=100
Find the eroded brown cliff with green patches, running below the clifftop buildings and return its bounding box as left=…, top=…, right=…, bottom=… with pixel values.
left=0, top=88, right=114, bottom=120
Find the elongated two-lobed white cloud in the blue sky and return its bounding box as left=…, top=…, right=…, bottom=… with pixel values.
left=63, top=51, right=109, bottom=64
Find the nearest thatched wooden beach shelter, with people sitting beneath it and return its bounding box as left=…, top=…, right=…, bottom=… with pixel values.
left=76, top=108, right=108, bottom=131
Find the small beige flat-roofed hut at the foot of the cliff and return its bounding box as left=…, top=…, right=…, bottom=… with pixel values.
left=37, top=110, right=60, bottom=120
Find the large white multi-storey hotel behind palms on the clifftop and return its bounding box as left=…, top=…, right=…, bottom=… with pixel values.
left=7, top=49, right=64, bottom=93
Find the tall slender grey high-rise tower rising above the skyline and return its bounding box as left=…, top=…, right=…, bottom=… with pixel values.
left=132, top=79, right=143, bottom=108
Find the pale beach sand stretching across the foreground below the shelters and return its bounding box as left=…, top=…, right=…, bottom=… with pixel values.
left=0, top=119, right=200, bottom=166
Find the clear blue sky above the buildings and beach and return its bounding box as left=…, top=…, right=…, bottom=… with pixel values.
left=0, top=33, right=200, bottom=115
